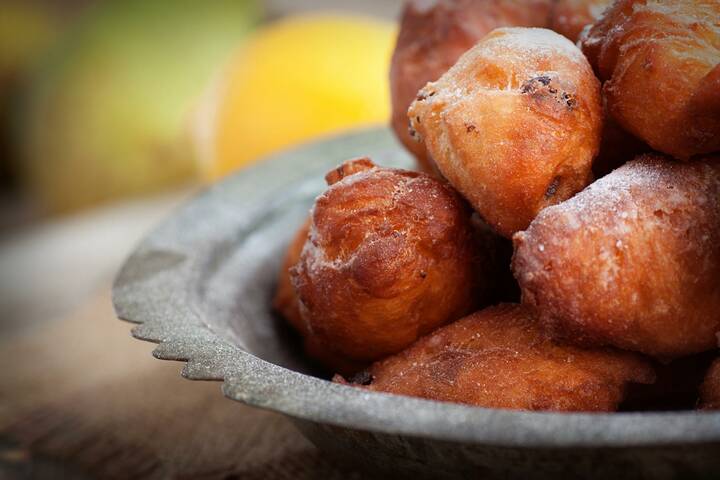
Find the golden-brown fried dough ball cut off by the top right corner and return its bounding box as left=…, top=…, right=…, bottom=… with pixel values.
left=581, top=0, right=720, bottom=160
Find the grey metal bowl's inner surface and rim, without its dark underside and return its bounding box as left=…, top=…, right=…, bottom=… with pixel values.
left=113, top=129, right=720, bottom=448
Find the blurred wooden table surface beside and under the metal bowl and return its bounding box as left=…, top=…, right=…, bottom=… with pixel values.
left=0, top=198, right=368, bottom=480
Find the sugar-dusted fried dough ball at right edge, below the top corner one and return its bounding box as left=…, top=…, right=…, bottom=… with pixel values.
left=513, top=155, right=720, bottom=358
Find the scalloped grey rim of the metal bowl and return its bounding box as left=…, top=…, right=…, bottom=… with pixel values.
left=113, top=128, right=720, bottom=448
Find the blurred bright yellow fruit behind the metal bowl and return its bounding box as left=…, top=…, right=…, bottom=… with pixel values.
left=195, top=14, right=396, bottom=179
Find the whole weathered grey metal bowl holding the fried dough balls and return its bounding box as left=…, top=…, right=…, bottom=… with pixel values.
left=113, top=129, right=720, bottom=478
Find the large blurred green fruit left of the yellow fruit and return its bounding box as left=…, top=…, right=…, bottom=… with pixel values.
left=24, top=0, right=259, bottom=212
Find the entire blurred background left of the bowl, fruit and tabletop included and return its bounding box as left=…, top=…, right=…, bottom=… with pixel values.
left=0, top=0, right=401, bottom=480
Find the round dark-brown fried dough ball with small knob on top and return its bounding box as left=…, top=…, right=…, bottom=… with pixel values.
left=291, top=159, right=489, bottom=362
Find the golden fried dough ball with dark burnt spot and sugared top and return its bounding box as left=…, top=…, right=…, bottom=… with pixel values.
left=408, top=28, right=602, bottom=237
